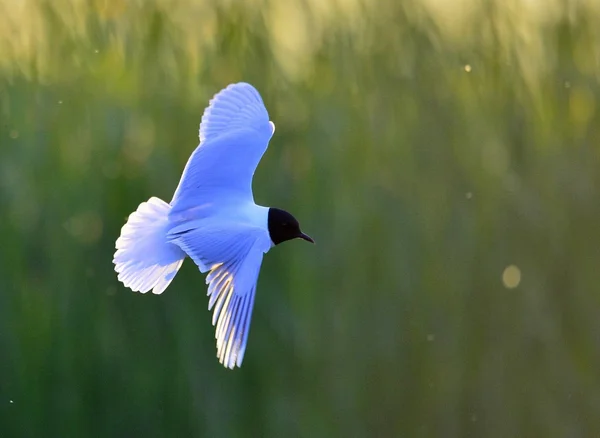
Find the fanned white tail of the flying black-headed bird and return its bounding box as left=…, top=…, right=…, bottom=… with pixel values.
left=113, top=198, right=185, bottom=294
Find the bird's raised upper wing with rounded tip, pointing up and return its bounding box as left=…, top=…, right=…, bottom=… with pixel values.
left=171, top=82, right=275, bottom=215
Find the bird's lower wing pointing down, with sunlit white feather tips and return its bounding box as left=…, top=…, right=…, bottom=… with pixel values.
left=168, top=224, right=271, bottom=369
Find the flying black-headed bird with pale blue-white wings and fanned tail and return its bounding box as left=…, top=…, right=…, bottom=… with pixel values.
left=113, top=83, right=314, bottom=369
